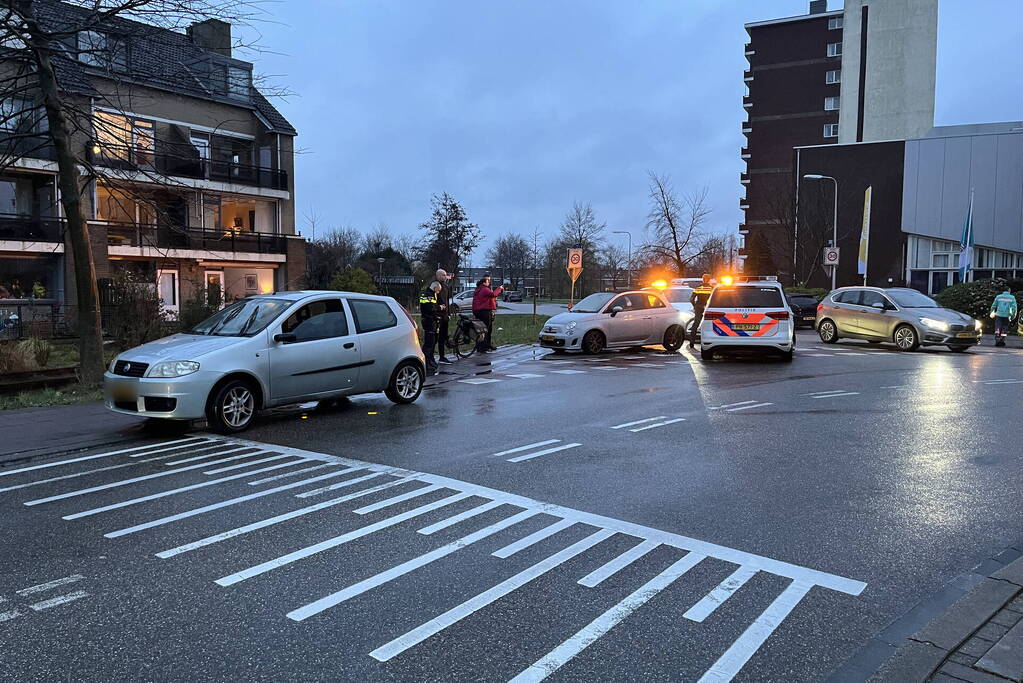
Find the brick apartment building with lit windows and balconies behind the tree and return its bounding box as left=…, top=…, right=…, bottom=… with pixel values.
left=0, top=1, right=306, bottom=331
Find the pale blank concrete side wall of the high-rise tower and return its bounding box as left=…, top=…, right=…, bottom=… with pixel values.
left=839, top=0, right=938, bottom=143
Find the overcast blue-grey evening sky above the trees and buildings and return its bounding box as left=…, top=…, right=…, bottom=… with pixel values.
left=239, top=0, right=1023, bottom=265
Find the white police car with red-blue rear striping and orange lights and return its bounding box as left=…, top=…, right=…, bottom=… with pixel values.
left=700, top=280, right=796, bottom=361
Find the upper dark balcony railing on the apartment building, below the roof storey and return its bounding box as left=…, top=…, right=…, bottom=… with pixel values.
left=88, top=143, right=287, bottom=190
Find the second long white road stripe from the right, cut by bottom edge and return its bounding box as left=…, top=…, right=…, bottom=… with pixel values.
left=510, top=552, right=704, bottom=683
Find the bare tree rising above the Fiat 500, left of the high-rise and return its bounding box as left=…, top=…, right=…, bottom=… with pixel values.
left=640, top=172, right=710, bottom=276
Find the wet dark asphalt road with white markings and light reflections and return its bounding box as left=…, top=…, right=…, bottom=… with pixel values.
left=0, top=327, right=1023, bottom=681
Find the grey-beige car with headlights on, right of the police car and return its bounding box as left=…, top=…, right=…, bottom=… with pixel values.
left=816, top=287, right=981, bottom=352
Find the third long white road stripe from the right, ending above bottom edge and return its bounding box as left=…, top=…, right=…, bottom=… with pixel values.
left=369, top=529, right=617, bottom=662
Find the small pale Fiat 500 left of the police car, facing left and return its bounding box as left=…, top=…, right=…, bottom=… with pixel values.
left=540, top=291, right=685, bottom=354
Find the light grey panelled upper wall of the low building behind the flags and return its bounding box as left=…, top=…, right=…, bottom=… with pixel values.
left=902, top=132, right=1023, bottom=252
